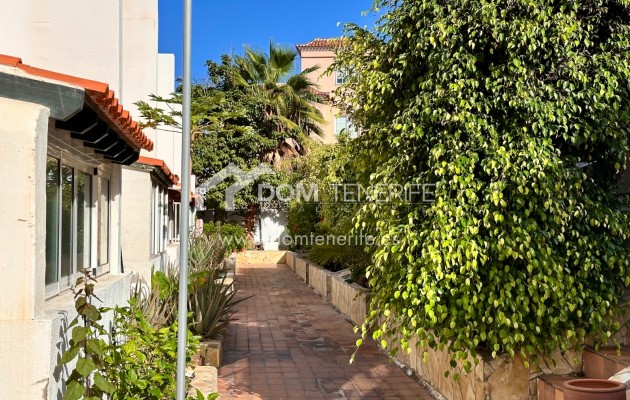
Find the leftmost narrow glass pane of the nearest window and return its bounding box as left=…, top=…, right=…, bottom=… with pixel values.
left=46, top=156, right=59, bottom=285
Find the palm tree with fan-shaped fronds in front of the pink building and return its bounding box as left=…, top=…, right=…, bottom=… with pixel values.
left=235, top=42, right=325, bottom=167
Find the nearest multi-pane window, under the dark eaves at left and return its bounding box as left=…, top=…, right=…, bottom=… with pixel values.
left=45, top=156, right=91, bottom=295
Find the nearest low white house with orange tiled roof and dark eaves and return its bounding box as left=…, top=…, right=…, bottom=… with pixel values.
left=0, top=56, right=153, bottom=399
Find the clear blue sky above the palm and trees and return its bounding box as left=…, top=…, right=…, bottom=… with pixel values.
left=159, top=0, right=375, bottom=79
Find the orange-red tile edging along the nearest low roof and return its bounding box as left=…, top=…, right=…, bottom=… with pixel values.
left=0, top=54, right=153, bottom=151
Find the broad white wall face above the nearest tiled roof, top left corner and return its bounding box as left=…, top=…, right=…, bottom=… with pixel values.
left=0, top=0, right=123, bottom=92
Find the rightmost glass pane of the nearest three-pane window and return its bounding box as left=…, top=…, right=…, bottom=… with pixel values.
left=76, top=172, right=92, bottom=271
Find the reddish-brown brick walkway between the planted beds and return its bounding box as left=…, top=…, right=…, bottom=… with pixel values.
left=219, top=265, right=432, bottom=400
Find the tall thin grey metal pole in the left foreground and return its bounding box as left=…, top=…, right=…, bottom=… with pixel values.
left=177, top=0, right=192, bottom=400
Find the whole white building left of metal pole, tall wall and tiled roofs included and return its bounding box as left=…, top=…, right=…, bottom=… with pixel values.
left=0, top=0, right=194, bottom=399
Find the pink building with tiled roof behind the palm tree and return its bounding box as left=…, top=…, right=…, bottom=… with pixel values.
left=296, top=38, right=356, bottom=143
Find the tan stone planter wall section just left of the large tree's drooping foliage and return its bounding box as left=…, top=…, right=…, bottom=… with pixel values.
left=330, top=270, right=369, bottom=325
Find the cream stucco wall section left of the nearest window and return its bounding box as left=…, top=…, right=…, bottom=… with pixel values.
left=0, top=97, right=50, bottom=318
